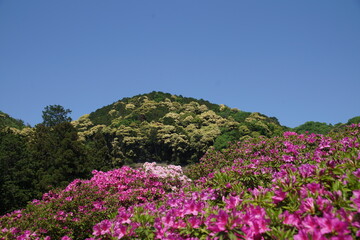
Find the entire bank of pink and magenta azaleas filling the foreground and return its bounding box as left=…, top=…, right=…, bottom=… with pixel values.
left=0, top=124, right=360, bottom=240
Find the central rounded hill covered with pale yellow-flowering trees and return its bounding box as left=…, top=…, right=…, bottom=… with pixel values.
left=73, top=92, right=285, bottom=164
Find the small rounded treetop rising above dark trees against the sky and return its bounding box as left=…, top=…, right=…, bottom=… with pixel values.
left=42, top=105, right=72, bottom=127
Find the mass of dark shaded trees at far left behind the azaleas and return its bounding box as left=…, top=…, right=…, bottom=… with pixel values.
left=0, top=123, right=98, bottom=213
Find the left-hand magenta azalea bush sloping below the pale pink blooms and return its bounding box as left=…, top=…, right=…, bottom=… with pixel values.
left=0, top=164, right=190, bottom=239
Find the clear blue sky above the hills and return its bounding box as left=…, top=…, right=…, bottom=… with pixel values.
left=0, top=0, right=360, bottom=127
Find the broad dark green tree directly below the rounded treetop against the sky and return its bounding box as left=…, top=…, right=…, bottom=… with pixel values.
left=27, top=122, right=92, bottom=195
